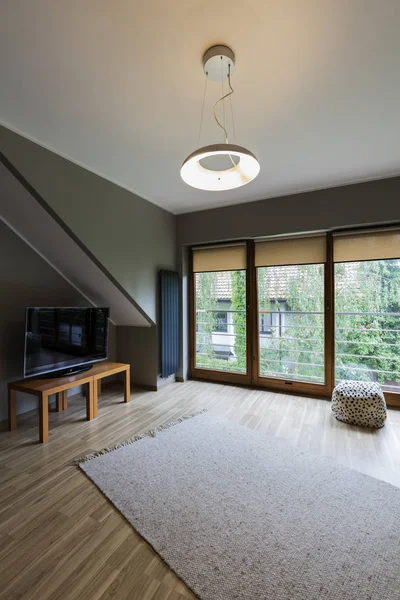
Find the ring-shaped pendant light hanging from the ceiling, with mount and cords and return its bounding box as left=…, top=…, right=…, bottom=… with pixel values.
left=181, top=46, right=260, bottom=192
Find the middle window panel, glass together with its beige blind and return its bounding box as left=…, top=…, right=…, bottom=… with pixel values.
left=255, top=236, right=326, bottom=385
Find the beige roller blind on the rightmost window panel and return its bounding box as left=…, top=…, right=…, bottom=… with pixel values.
left=333, top=229, right=400, bottom=262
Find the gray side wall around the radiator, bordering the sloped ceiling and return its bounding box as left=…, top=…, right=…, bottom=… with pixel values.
left=0, top=126, right=177, bottom=387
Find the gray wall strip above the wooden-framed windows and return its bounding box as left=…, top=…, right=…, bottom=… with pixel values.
left=177, top=177, right=400, bottom=246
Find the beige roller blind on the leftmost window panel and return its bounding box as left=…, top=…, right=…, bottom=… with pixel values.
left=193, top=244, right=246, bottom=273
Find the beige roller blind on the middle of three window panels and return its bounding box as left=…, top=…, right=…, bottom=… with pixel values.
left=255, top=235, right=326, bottom=267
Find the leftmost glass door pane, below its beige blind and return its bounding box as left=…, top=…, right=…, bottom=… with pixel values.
left=194, top=270, right=247, bottom=374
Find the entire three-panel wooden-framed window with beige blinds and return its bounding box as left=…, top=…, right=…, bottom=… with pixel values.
left=191, top=228, right=400, bottom=406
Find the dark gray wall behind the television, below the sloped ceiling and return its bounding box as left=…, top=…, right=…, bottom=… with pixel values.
left=0, top=221, right=116, bottom=420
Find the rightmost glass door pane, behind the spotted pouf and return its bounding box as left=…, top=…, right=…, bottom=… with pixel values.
left=335, top=259, right=400, bottom=392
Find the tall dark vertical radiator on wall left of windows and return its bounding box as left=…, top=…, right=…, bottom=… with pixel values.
left=160, top=270, right=179, bottom=377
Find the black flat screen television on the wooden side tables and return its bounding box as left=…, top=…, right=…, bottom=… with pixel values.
left=24, top=307, right=109, bottom=377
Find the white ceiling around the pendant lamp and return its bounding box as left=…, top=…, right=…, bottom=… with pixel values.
left=0, top=0, right=400, bottom=213
